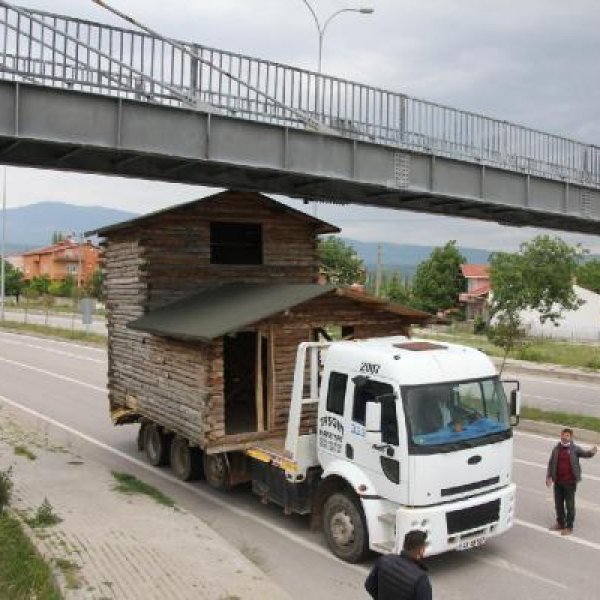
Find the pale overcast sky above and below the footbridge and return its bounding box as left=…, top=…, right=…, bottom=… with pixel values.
left=1, top=0, right=600, bottom=252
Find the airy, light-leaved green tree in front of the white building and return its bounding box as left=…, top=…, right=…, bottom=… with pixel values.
left=488, top=235, right=584, bottom=372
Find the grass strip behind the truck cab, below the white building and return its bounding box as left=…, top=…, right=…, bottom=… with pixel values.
left=419, top=329, right=600, bottom=370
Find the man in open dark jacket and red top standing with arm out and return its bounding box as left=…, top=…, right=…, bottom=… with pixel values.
left=546, top=429, right=598, bottom=535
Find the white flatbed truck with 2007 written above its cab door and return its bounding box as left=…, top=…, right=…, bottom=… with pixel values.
left=138, top=337, right=520, bottom=562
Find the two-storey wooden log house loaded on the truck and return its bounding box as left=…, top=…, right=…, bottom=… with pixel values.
left=93, top=191, right=429, bottom=453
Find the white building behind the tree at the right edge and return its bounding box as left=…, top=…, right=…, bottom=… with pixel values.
left=521, top=285, right=600, bottom=342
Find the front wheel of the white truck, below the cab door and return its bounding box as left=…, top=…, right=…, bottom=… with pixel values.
left=323, top=492, right=369, bottom=563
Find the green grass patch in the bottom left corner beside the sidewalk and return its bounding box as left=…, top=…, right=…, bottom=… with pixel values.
left=0, top=513, right=61, bottom=600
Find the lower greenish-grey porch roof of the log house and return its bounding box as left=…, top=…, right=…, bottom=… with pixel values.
left=127, top=283, right=430, bottom=342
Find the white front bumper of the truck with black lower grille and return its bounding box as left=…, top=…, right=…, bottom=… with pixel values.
left=395, top=483, right=516, bottom=556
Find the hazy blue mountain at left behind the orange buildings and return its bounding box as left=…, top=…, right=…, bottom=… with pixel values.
left=6, top=202, right=138, bottom=254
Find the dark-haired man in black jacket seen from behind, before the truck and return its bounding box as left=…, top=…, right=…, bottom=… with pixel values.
left=365, top=529, right=432, bottom=600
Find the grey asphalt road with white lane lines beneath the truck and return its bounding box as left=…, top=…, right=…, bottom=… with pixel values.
left=0, top=332, right=600, bottom=600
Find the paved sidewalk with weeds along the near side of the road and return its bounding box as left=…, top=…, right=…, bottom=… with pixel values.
left=0, top=411, right=289, bottom=600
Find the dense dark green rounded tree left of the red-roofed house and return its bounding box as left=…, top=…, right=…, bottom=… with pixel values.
left=412, top=240, right=466, bottom=313
